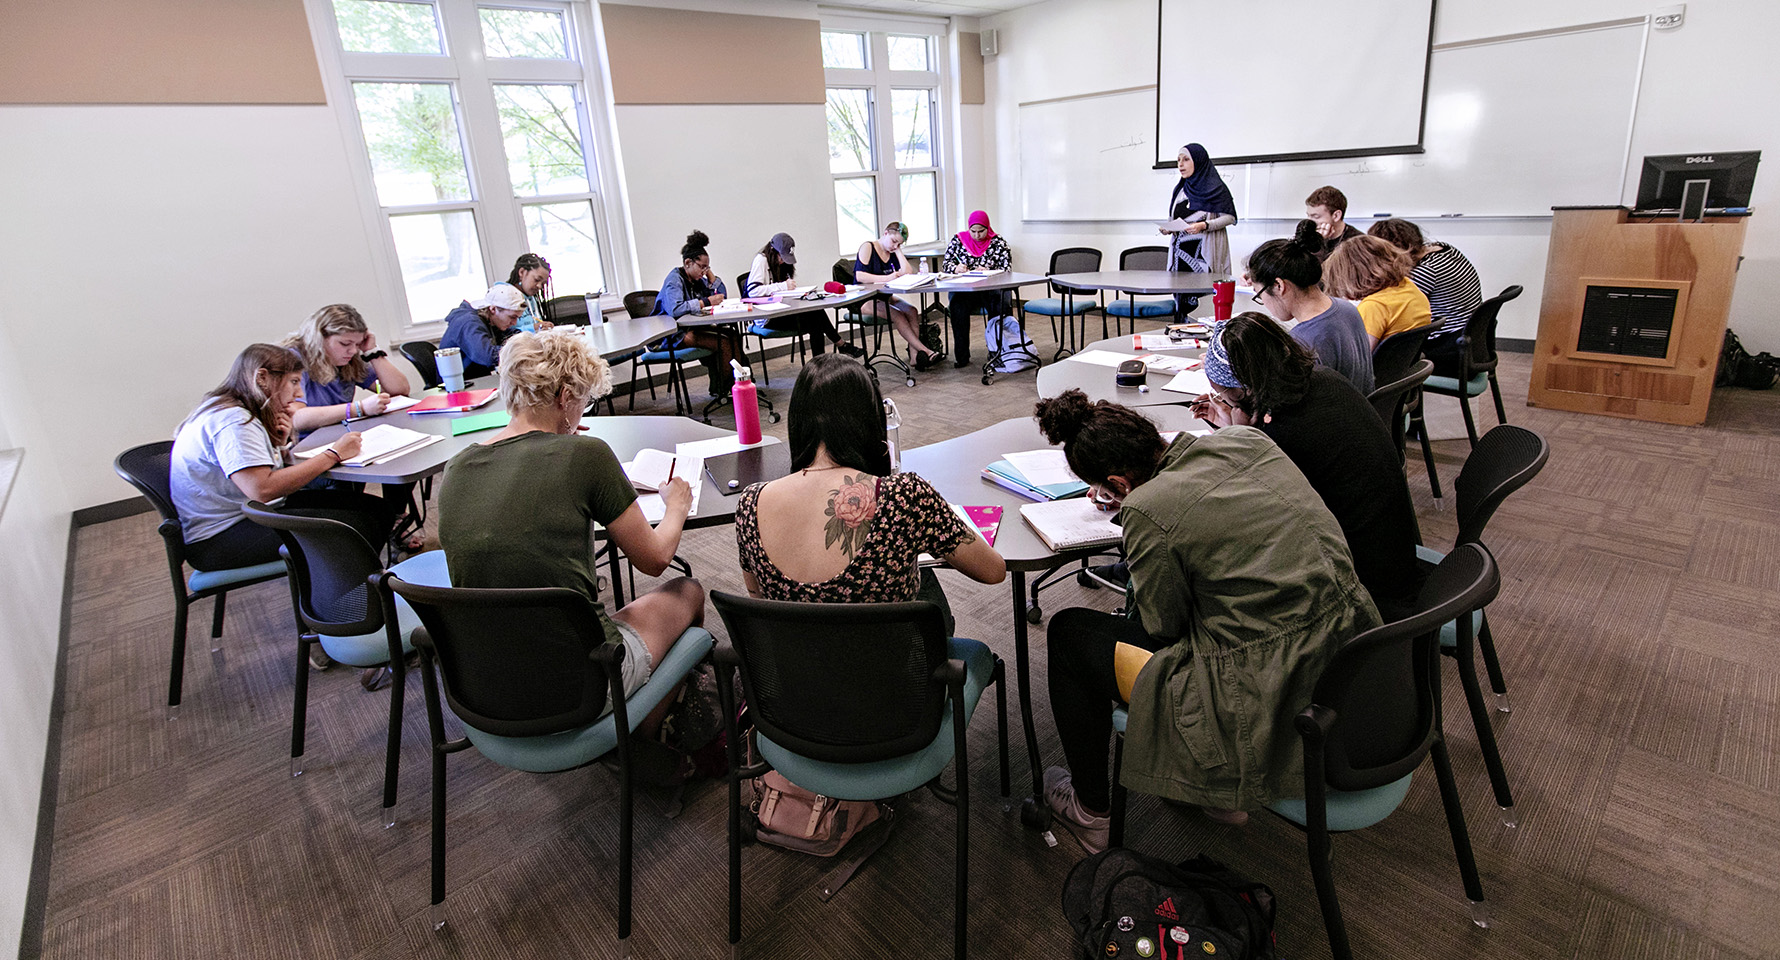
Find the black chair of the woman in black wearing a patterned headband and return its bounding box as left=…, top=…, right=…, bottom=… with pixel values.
left=1415, top=424, right=1550, bottom=826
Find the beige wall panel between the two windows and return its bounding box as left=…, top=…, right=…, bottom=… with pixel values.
left=600, top=4, right=826, bottom=103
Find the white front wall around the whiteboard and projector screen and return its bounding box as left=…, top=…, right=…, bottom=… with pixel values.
left=983, top=0, right=1780, bottom=351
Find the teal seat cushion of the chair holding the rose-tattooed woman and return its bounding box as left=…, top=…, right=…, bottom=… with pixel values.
left=758, top=638, right=995, bottom=800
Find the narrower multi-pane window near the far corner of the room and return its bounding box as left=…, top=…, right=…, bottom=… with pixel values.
left=822, top=28, right=945, bottom=255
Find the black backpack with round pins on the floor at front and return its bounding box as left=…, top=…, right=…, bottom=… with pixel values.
left=1063, top=848, right=1274, bottom=960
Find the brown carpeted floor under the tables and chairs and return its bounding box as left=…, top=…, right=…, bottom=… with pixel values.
left=31, top=317, right=1780, bottom=960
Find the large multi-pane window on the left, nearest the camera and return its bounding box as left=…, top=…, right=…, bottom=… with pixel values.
left=320, top=0, right=612, bottom=324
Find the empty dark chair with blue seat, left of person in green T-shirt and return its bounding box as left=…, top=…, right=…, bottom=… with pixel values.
left=242, top=500, right=450, bottom=826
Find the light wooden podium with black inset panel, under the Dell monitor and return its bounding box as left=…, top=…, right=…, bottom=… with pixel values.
left=1527, top=207, right=1748, bottom=426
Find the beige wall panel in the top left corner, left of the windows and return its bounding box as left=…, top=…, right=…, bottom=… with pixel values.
left=0, top=0, right=328, bottom=103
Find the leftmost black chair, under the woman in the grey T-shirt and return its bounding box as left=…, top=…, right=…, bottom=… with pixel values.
left=112, top=440, right=285, bottom=720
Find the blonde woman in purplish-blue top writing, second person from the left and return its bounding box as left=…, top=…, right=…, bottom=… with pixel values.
left=285, top=303, right=424, bottom=550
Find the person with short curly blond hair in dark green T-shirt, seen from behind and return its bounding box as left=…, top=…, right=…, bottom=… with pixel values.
left=440, top=333, right=705, bottom=737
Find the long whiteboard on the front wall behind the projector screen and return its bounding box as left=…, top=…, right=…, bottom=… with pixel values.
left=1018, top=18, right=1645, bottom=221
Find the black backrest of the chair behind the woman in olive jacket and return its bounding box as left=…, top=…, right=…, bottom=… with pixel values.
left=1299, top=545, right=1501, bottom=791
